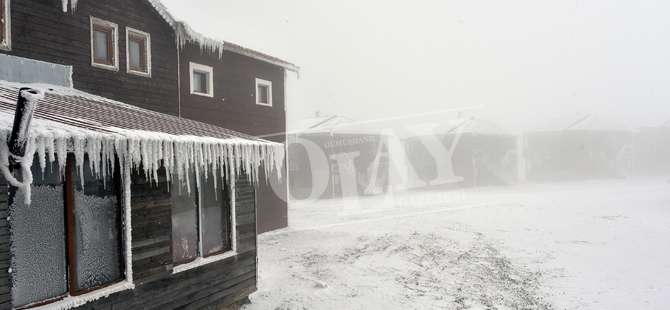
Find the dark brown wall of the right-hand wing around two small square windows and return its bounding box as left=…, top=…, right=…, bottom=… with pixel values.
left=180, top=44, right=288, bottom=233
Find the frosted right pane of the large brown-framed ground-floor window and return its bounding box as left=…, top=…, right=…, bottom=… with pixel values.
left=71, top=156, right=121, bottom=291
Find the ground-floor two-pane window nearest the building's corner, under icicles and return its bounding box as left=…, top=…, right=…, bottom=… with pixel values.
left=170, top=166, right=233, bottom=266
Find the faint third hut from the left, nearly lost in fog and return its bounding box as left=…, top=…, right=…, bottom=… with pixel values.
left=524, top=114, right=633, bottom=180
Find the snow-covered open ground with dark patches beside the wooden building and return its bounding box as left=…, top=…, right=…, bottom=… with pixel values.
left=244, top=177, right=670, bottom=309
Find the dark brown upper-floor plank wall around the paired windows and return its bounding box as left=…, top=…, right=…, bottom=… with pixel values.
left=0, top=0, right=179, bottom=115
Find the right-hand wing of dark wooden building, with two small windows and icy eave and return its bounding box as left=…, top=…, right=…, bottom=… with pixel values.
left=176, top=22, right=298, bottom=233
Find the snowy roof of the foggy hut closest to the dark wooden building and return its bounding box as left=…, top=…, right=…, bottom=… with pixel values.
left=289, top=115, right=380, bottom=135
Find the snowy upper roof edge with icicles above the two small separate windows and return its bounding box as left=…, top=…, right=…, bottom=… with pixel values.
left=62, top=0, right=300, bottom=74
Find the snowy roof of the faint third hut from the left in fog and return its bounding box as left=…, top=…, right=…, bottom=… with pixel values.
left=527, top=114, right=633, bottom=133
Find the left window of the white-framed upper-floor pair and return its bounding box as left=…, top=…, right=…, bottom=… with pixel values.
left=91, top=17, right=119, bottom=70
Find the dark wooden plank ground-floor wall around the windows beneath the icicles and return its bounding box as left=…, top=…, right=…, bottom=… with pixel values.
left=79, top=170, right=257, bottom=309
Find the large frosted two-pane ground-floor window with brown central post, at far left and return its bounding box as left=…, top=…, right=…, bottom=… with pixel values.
left=9, top=155, right=124, bottom=308
